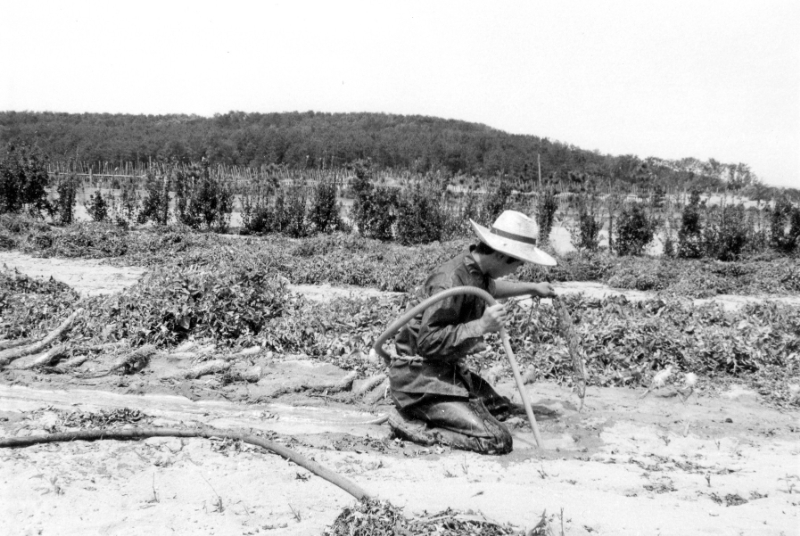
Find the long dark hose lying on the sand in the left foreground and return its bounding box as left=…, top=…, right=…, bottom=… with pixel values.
left=0, top=428, right=374, bottom=500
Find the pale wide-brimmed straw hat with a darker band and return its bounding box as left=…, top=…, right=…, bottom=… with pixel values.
left=469, top=210, right=556, bottom=266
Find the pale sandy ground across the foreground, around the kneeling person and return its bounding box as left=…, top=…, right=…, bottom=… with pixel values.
left=0, top=253, right=800, bottom=535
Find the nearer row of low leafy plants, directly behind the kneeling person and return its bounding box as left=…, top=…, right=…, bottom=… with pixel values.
left=0, top=266, right=800, bottom=403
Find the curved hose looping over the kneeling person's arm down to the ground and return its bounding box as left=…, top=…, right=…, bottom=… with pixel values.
left=372, top=287, right=543, bottom=448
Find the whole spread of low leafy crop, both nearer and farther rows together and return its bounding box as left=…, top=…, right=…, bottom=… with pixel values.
left=0, top=220, right=800, bottom=401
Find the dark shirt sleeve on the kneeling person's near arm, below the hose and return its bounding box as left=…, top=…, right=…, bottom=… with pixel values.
left=417, top=281, right=483, bottom=360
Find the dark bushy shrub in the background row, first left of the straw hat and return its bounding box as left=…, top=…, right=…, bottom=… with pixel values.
left=396, top=184, right=443, bottom=245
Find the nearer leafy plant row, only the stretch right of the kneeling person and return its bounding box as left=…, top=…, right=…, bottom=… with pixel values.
left=507, top=297, right=800, bottom=398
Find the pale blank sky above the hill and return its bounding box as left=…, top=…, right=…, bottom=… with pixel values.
left=0, top=0, right=800, bottom=187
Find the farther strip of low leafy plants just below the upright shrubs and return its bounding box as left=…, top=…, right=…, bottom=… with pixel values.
left=0, top=220, right=800, bottom=298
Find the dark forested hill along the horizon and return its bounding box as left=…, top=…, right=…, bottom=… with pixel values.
left=0, top=112, right=755, bottom=192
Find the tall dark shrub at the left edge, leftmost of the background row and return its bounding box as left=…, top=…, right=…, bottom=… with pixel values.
left=0, top=143, right=53, bottom=215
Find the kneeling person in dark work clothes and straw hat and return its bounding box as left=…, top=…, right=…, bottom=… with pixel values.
left=389, top=210, right=556, bottom=454
